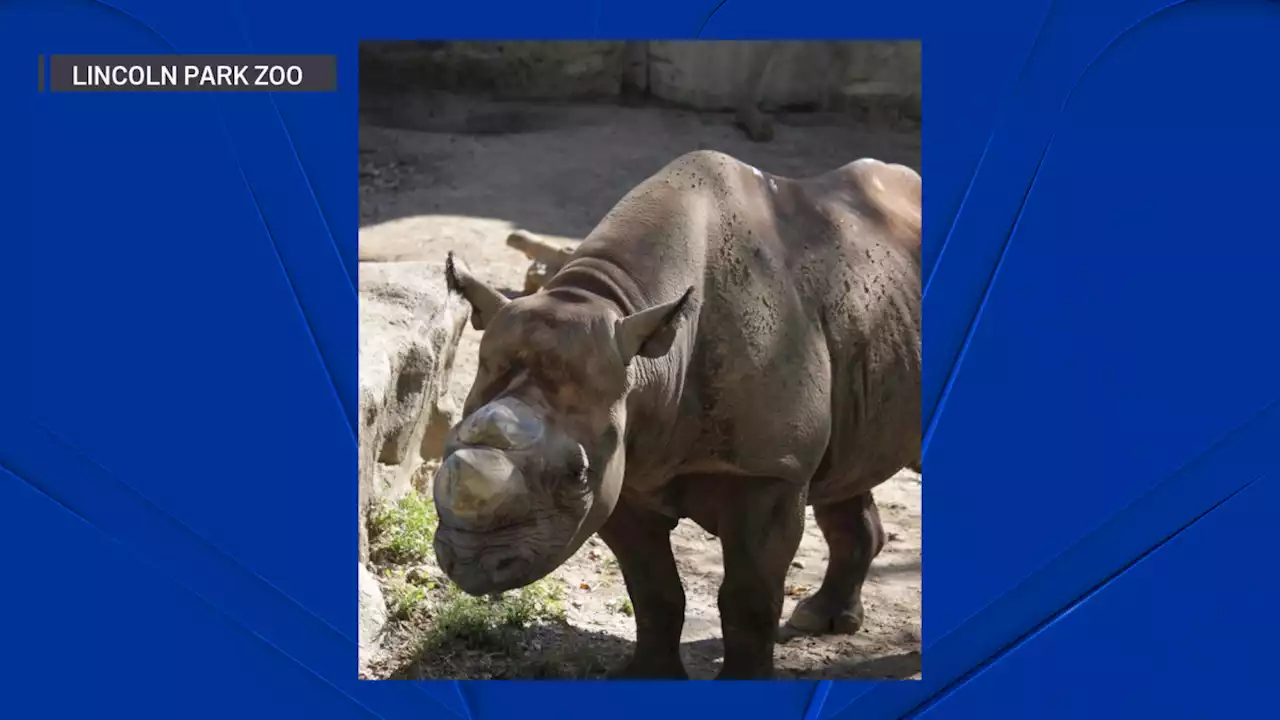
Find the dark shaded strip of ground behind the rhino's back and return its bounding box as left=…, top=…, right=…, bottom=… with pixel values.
left=360, top=94, right=920, bottom=242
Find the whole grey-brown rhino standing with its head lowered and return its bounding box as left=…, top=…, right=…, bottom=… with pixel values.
left=434, top=151, right=920, bottom=679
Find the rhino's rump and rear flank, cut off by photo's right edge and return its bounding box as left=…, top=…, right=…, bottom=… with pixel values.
left=788, top=160, right=922, bottom=503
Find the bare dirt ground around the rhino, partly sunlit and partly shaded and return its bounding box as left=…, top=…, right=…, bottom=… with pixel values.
left=360, top=99, right=920, bottom=679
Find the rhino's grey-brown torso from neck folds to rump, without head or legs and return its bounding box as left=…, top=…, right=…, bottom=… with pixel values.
left=570, top=151, right=919, bottom=497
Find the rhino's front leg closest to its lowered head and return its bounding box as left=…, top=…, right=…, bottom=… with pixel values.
left=599, top=500, right=689, bottom=680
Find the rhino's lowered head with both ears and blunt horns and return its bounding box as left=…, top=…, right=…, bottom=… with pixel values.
left=434, top=254, right=689, bottom=594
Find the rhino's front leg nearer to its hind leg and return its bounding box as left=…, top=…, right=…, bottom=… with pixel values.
left=717, top=478, right=805, bottom=680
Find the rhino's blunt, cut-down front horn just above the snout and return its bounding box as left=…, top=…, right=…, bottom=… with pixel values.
left=434, top=447, right=529, bottom=525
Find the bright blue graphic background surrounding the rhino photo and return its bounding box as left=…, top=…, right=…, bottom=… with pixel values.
left=0, top=0, right=1280, bottom=719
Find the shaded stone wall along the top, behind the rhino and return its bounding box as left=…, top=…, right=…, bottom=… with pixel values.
left=360, top=40, right=920, bottom=116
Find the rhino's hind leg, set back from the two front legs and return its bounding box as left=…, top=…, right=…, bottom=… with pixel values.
left=787, top=492, right=884, bottom=634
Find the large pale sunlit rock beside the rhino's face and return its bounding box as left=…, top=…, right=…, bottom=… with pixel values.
left=358, top=263, right=470, bottom=561
